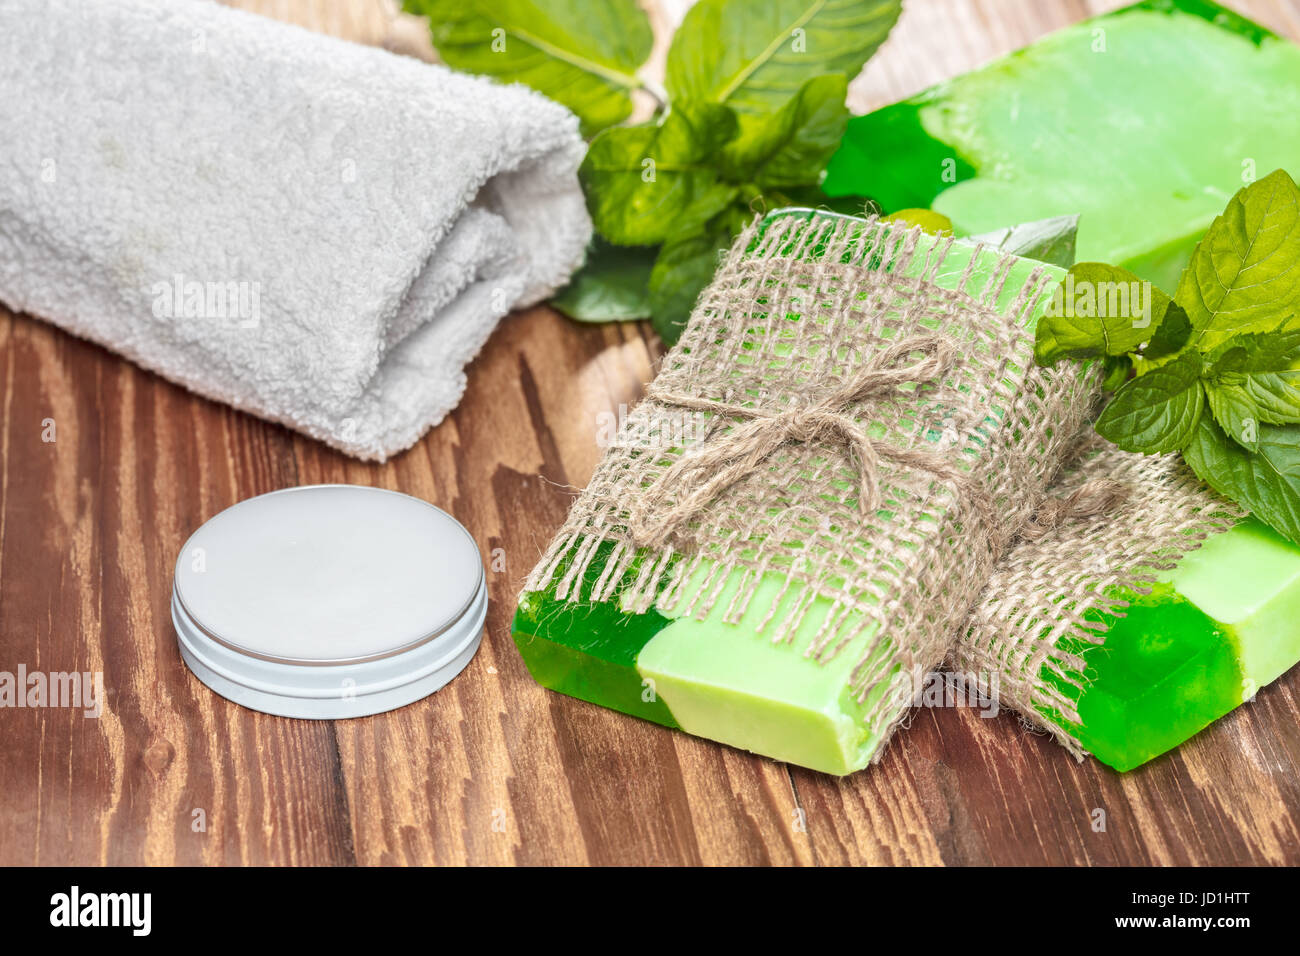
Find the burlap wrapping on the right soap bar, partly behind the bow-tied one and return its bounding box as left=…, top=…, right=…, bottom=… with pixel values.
left=949, top=429, right=1244, bottom=758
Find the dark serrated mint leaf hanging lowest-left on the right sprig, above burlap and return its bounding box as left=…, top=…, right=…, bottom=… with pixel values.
left=1097, top=354, right=1205, bottom=455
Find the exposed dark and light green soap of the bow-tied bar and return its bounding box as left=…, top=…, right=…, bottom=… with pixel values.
left=512, top=230, right=1065, bottom=774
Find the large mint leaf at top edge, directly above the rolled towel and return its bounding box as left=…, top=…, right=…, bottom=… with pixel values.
left=406, top=0, right=654, bottom=137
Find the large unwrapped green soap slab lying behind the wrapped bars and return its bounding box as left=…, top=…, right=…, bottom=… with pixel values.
left=824, top=0, right=1300, bottom=291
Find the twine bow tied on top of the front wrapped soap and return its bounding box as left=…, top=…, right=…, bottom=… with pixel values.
left=628, top=336, right=1002, bottom=557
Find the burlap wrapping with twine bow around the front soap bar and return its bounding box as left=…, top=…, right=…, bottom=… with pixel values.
left=525, top=216, right=1096, bottom=753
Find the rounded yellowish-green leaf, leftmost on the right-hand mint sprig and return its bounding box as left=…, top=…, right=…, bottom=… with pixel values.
left=1034, top=263, right=1173, bottom=365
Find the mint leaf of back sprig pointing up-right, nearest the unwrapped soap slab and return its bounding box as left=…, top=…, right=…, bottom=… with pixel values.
left=723, top=74, right=849, bottom=190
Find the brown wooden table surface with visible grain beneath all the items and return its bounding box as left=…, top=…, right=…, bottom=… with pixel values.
left=0, top=0, right=1300, bottom=864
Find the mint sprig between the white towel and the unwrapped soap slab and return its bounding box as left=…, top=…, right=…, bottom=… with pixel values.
left=404, top=0, right=901, bottom=343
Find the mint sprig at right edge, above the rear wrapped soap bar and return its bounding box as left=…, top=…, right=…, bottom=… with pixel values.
left=1035, top=169, right=1300, bottom=544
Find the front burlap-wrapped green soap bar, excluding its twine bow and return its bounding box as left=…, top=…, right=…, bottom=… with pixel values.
left=514, top=216, right=1093, bottom=774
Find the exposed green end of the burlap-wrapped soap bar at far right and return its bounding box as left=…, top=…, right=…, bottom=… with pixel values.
left=1043, top=519, right=1300, bottom=770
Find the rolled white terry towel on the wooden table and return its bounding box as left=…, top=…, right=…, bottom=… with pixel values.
left=0, top=0, right=590, bottom=460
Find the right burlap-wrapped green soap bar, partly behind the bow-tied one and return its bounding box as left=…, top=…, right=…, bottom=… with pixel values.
left=952, top=437, right=1300, bottom=770
